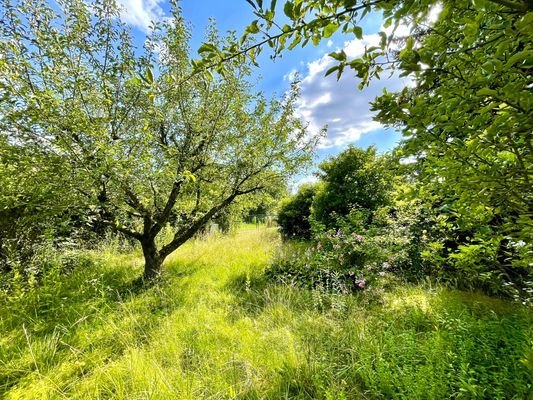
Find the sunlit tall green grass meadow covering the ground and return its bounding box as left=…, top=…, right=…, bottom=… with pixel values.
left=0, top=227, right=533, bottom=400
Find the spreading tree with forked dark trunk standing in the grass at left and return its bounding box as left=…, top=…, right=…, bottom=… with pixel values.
left=0, top=0, right=315, bottom=278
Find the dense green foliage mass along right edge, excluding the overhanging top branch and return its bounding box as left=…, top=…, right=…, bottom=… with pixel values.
left=374, top=2, right=533, bottom=300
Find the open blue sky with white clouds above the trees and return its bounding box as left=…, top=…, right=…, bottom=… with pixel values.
left=119, top=0, right=407, bottom=186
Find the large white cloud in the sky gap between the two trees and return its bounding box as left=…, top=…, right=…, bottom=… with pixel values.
left=297, top=34, right=409, bottom=148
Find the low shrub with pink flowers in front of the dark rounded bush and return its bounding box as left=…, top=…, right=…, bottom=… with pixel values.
left=266, top=211, right=408, bottom=294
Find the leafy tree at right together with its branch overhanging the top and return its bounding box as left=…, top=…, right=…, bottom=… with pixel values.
left=194, top=0, right=533, bottom=298
